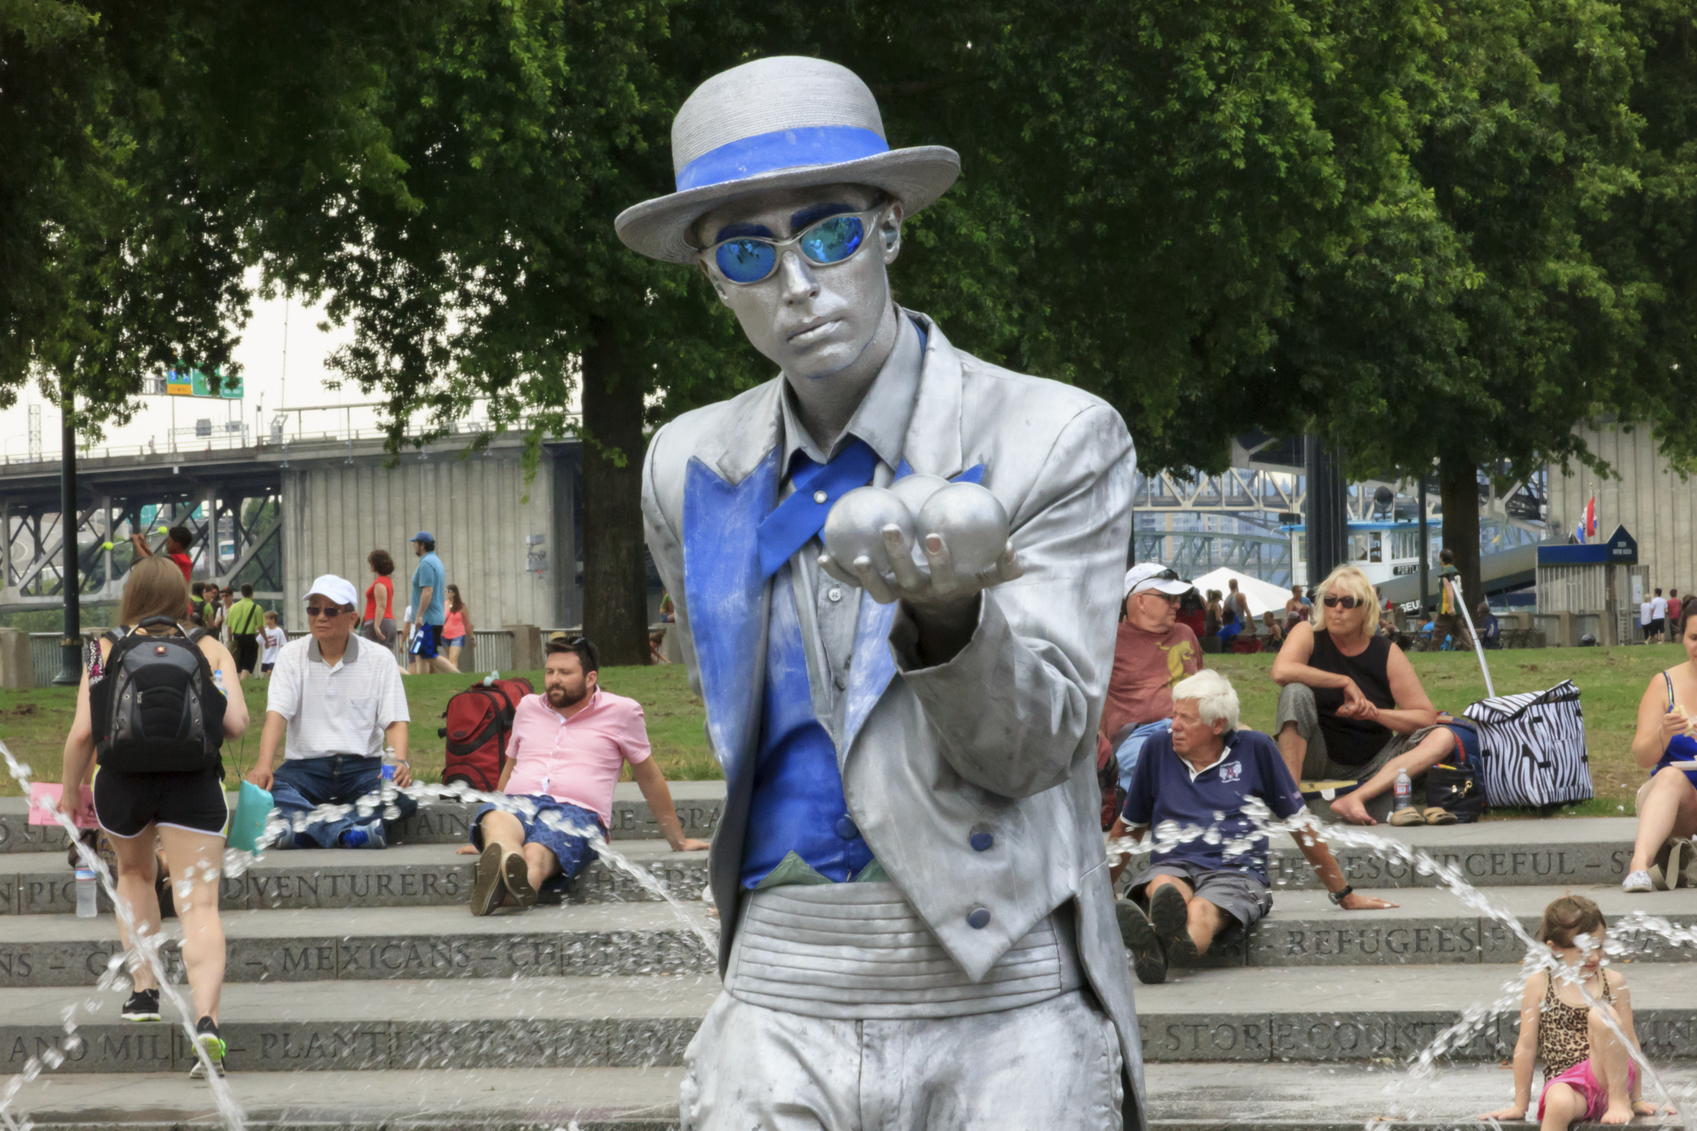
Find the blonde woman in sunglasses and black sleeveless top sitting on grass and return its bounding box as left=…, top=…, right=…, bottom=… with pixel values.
left=1273, top=566, right=1437, bottom=820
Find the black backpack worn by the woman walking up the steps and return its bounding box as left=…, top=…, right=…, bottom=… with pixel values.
left=88, top=616, right=226, bottom=774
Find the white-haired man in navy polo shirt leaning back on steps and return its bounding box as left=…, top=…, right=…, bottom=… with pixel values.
left=1108, top=671, right=1395, bottom=982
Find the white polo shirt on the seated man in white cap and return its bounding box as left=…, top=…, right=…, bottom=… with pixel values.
left=265, top=624, right=412, bottom=759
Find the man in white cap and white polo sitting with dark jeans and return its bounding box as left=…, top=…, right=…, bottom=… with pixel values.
left=248, top=574, right=417, bottom=849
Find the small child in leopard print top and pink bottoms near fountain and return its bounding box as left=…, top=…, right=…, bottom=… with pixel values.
left=1480, top=895, right=1672, bottom=1131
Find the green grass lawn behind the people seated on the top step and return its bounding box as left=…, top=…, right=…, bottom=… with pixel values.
left=0, top=644, right=1685, bottom=817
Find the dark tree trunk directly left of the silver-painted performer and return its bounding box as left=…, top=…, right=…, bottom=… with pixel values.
left=584, top=331, right=648, bottom=666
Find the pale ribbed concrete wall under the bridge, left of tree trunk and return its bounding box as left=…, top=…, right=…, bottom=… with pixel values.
left=283, top=438, right=577, bottom=630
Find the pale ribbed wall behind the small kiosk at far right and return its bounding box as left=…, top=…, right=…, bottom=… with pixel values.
left=1539, top=425, right=1697, bottom=594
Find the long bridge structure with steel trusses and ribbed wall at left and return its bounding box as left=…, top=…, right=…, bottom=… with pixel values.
left=0, top=406, right=582, bottom=630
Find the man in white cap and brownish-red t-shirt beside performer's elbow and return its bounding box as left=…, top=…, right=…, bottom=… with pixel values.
left=1100, top=562, right=1203, bottom=811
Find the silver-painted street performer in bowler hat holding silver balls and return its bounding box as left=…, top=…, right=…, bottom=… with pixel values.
left=616, top=58, right=1144, bottom=1131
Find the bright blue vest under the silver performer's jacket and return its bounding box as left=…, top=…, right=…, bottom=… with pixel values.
left=742, top=566, right=872, bottom=888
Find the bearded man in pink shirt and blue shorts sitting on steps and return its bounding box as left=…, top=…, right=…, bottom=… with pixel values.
left=462, top=640, right=708, bottom=915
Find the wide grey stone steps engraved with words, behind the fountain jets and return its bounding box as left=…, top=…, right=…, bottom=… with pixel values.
left=0, top=783, right=1697, bottom=1131
